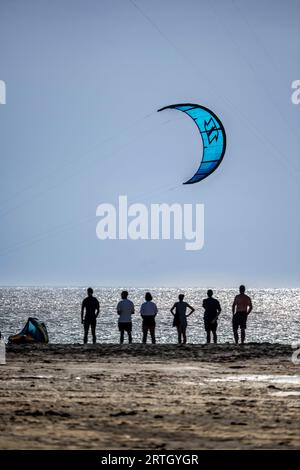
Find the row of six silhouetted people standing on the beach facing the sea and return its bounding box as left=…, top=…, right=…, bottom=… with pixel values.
left=81, top=285, right=252, bottom=344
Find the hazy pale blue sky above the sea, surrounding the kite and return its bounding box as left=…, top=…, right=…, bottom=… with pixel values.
left=0, top=0, right=300, bottom=288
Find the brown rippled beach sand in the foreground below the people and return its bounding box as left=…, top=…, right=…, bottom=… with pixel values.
left=0, top=343, right=300, bottom=450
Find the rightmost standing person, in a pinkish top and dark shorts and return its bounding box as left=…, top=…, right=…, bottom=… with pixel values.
left=232, top=285, right=252, bottom=344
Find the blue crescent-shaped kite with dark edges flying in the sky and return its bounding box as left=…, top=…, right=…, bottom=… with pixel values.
left=158, top=103, right=226, bottom=184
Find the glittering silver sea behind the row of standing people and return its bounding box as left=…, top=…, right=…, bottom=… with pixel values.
left=0, top=287, right=300, bottom=344
